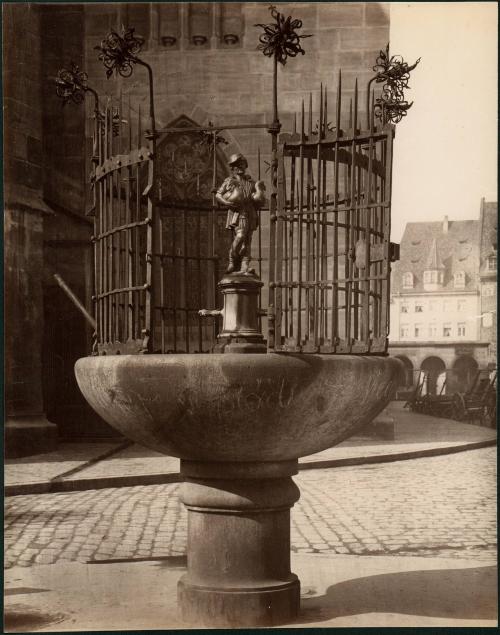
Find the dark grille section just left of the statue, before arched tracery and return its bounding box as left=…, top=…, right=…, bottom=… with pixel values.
left=153, top=117, right=230, bottom=353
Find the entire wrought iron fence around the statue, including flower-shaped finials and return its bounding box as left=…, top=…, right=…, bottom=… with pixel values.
left=55, top=7, right=418, bottom=354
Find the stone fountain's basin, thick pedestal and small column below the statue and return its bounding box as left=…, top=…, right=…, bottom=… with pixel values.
left=76, top=266, right=400, bottom=627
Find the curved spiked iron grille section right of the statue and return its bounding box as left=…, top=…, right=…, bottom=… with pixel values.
left=269, top=78, right=396, bottom=354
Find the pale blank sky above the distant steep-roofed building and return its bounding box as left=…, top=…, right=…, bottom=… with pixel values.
left=390, top=2, right=498, bottom=242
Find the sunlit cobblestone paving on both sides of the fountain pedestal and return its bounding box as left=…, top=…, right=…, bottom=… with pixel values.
left=5, top=448, right=496, bottom=567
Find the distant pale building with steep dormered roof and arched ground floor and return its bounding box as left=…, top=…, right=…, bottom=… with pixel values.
left=389, top=199, right=497, bottom=393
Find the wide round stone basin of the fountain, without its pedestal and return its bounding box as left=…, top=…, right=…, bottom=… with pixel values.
left=75, top=353, right=400, bottom=461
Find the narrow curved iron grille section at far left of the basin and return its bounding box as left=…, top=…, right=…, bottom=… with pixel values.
left=93, top=101, right=150, bottom=354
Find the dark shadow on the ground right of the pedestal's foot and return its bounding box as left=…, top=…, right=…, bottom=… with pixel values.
left=300, top=566, right=497, bottom=622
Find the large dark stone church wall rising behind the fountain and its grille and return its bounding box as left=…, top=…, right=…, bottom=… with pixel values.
left=3, top=2, right=389, bottom=456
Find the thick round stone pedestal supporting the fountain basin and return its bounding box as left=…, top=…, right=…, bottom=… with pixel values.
left=178, top=461, right=300, bottom=628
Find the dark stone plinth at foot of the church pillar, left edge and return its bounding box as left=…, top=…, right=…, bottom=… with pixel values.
left=4, top=415, right=57, bottom=459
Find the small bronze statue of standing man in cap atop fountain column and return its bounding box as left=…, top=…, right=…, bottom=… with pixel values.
left=215, top=154, right=266, bottom=274
